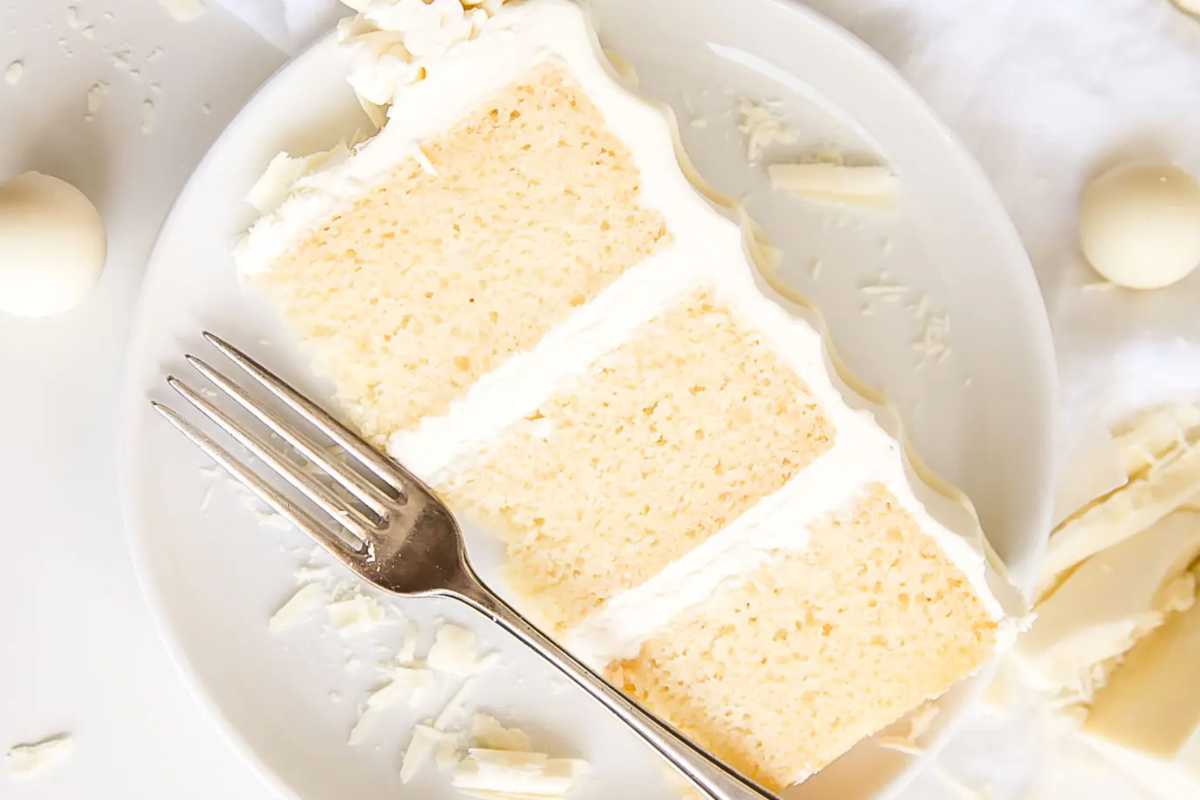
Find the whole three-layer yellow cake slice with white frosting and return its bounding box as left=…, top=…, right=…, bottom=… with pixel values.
left=236, top=0, right=1022, bottom=789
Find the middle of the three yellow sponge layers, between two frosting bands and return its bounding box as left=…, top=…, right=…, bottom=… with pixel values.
left=440, top=291, right=834, bottom=628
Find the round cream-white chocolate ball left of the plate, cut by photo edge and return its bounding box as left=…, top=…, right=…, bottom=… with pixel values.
left=0, top=173, right=106, bottom=317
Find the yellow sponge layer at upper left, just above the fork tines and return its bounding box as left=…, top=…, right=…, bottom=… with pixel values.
left=252, top=61, right=668, bottom=445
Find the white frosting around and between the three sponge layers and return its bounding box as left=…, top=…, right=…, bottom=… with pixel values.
left=238, top=0, right=1004, bottom=664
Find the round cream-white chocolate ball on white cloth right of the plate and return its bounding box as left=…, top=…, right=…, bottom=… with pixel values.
left=1079, top=162, right=1200, bottom=289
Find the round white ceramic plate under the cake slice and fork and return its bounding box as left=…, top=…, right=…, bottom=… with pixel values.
left=121, top=0, right=1054, bottom=800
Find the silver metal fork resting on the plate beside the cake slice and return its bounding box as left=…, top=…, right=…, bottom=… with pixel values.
left=151, top=332, right=778, bottom=800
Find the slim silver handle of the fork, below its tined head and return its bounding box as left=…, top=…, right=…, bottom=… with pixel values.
left=444, top=564, right=779, bottom=800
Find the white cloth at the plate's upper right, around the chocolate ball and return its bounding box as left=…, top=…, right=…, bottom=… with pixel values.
left=809, top=0, right=1200, bottom=506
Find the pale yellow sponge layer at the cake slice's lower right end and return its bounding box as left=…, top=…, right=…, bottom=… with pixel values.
left=607, top=485, right=997, bottom=790
